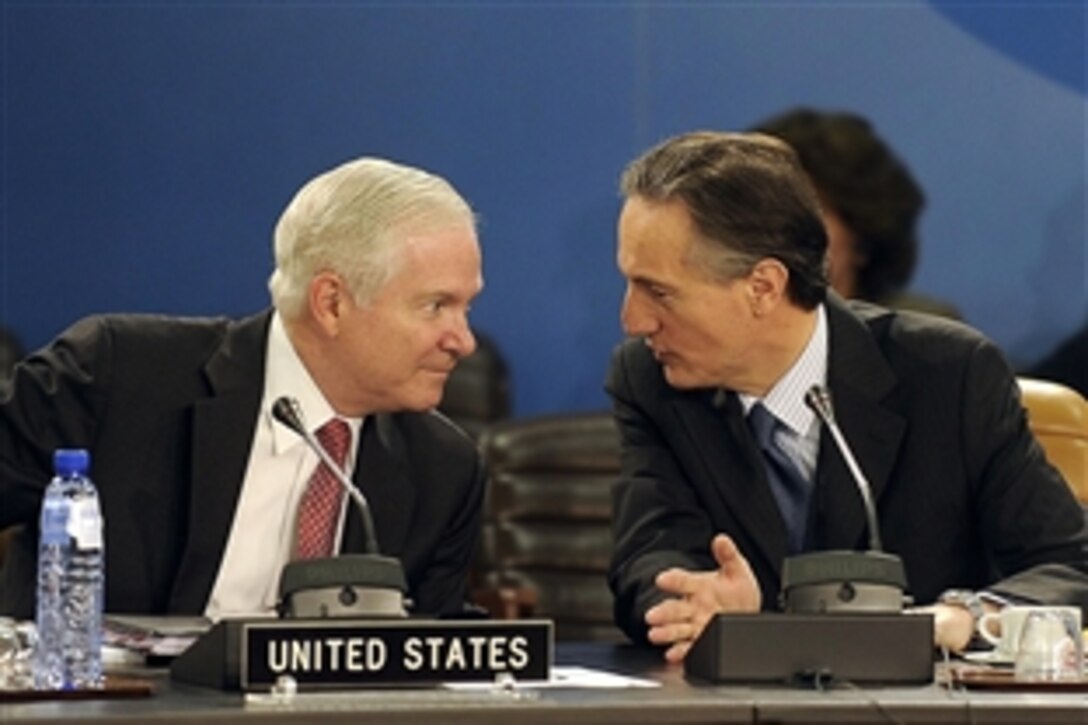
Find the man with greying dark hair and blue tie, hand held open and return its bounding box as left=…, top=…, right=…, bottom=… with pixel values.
left=607, top=128, right=1088, bottom=661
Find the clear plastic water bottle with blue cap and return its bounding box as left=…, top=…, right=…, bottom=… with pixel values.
left=34, top=450, right=104, bottom=690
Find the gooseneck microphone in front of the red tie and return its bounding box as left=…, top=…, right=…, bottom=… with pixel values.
left=272, top=395, right=408, bottom=617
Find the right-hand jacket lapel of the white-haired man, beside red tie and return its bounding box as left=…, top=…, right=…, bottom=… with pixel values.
left=344, top=414, right=416, bottom=556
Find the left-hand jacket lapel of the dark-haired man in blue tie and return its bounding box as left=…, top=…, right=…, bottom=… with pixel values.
left=675, top=392, right=787, bottom=575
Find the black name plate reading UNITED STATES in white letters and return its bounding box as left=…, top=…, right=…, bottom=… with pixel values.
left=170, top=618, right=555, bottom=691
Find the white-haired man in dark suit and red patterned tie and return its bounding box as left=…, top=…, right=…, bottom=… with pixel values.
left=0, top=158, right=484, bottom=619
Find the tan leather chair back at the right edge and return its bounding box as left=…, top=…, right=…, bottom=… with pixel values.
left=1017, top=377, right=1088, bottom=506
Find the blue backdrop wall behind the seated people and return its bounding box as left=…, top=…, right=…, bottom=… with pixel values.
left=0, top=0, right=1088, bottom=415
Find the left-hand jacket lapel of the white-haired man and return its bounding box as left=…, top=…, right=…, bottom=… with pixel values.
left=170, top=312, right=271, bottom=612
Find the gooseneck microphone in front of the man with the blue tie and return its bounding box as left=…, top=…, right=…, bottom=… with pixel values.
left=781, top=385, right=906, bottom=614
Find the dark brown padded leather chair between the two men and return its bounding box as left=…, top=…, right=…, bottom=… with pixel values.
left=472, top=413, right=625, bottom=641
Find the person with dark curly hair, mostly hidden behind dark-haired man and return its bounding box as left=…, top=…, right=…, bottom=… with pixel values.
left=752, top=108, right=962, bottom=319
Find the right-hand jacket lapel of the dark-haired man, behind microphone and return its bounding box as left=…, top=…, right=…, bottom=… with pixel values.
left=817, top=295, right=906, bottom=549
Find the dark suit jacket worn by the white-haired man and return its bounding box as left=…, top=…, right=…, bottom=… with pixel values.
left=0, top=312, right=484, bottom=616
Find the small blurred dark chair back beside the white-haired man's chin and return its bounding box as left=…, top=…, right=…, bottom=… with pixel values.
left=438, top=331, right=510, bottom=440
